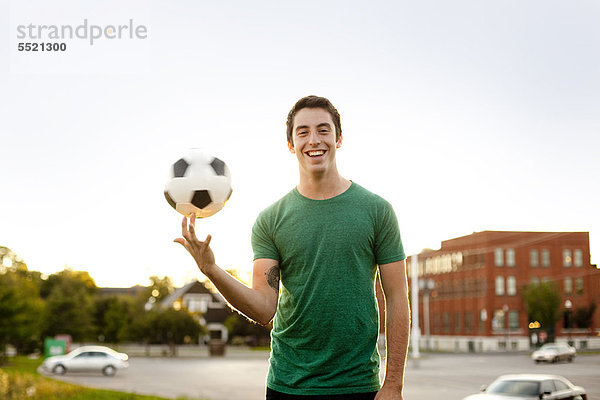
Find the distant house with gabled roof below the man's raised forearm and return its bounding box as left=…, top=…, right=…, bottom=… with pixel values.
left=160, top=281, right=234, bottom=341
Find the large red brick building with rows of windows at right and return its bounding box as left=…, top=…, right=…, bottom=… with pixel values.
left=398, top=231, right=600, bottom=351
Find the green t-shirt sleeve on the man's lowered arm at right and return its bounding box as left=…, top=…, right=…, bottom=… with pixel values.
left=374, top=201, right=406, bottom=265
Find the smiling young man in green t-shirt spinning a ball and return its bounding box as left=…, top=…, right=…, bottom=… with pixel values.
left=176, top=96, right=409, bottom=400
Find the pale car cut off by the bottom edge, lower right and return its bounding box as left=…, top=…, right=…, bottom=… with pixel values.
left=463, top=374, right=587, bottom=400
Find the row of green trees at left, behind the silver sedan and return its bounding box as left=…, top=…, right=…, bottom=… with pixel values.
left=0, top=246, right=209, bottom=354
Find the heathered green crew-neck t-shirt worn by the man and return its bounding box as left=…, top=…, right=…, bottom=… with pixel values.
left=252, top=183, right=405, bottom=395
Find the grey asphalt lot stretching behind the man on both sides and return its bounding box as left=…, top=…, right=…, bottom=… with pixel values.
left=44, top=351, right=600, bottom=400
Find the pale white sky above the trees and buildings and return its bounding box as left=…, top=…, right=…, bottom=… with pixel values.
left=0, top=0, right=600, bottom=286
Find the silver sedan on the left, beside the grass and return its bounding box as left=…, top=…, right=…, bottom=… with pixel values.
left=42, top=346, right=129, bottom=376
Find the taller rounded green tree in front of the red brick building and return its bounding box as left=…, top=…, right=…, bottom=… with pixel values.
left=523, top=282, right=562, bottom=342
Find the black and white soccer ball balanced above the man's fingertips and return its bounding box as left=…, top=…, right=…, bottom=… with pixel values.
left=165, top=149, right=232, bottom=218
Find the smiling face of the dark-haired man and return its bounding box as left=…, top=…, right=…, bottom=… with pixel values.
left=288, top=108, right=342, bottom=175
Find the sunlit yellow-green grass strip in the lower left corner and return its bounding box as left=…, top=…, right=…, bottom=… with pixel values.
left=0, top=357, right=203, bottom=400
